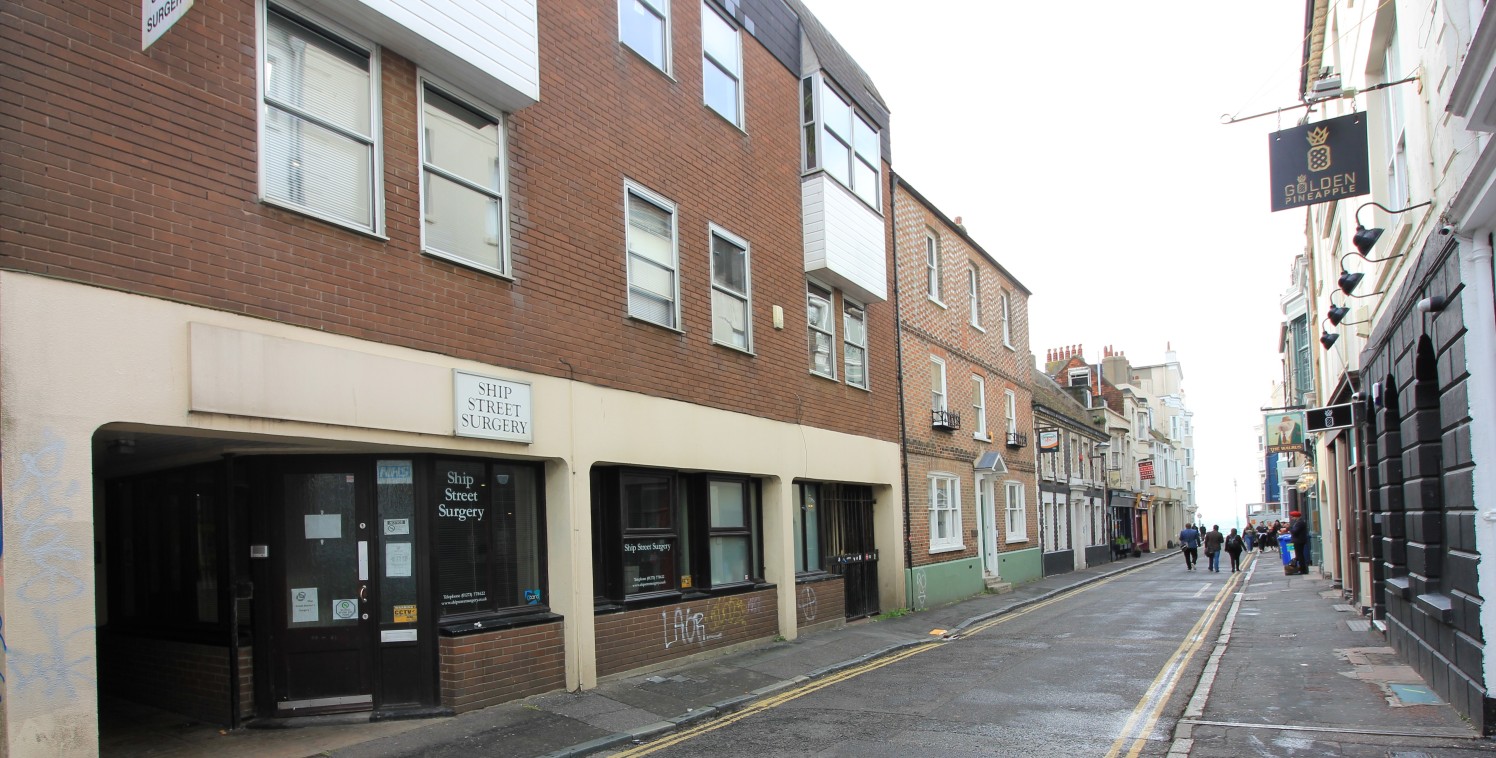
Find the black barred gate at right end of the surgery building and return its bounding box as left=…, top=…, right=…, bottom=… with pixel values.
left=821, top=484, right=878, bottom=619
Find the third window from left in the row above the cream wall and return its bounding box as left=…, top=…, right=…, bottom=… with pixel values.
left=624, top=182, right=681, bottom=329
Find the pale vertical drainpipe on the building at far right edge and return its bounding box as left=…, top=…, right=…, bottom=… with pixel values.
left=1459, top=229, right=1496, bottom=693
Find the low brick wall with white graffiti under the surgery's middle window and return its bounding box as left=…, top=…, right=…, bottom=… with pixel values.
left=597, top=589, right=779, bottom=676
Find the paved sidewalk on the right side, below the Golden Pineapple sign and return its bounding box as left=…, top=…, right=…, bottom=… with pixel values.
left=1170, top=553, right=1496, bottom=758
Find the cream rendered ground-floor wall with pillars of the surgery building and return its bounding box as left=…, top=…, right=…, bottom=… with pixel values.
left=0, top=272, right=904, bottom=755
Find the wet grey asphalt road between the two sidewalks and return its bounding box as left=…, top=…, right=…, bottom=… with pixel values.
left=612, top=559, right=1245, bottom=758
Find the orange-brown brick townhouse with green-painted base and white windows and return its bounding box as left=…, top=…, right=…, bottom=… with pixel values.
left=893, top=176, right=1043, bottom=608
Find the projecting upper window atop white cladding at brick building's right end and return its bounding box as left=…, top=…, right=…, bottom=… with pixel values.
left=802, top=76, right=883, bottom=208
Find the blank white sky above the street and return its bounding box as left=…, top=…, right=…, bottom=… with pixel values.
left=805, top=0, right=1305, bottom=526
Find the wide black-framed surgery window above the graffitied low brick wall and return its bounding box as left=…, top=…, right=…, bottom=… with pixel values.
left=592, top=466, right=763, bottom=603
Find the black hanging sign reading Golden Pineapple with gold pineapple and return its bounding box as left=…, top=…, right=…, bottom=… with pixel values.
left=1267, top=112, right=1372, bottom=211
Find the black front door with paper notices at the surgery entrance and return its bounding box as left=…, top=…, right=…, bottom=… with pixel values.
left=268, top=459, right=377, bottom=716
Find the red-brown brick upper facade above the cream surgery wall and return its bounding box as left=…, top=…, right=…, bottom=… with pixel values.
left=0, top=0, right=898, bottom=441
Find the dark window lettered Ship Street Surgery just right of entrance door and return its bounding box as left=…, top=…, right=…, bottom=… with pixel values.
left=431, top=460, right=546, bottom=619
